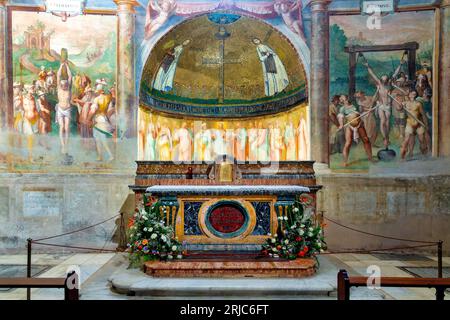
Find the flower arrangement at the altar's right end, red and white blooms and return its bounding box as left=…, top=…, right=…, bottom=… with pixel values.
left=261, top=200, right=326, bottom=260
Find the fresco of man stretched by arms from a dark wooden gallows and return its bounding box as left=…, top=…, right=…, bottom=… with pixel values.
left=329, top=12, right=434, bottom=169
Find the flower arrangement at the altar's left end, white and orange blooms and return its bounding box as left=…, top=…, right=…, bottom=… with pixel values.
left=128, top=197, right=183, bottom=266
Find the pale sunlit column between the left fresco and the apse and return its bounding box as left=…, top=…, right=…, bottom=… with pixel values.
left=114, top=0, right=138, bottom=137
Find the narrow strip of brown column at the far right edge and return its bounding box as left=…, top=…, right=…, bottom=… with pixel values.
left=437, top=0, right=450, bottom=157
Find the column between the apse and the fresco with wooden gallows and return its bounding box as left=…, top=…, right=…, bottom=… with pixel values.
left=310, top=0, right=331, bottom=167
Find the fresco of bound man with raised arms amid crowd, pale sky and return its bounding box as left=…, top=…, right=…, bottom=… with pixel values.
left=1, top=10, right=124, bottom=171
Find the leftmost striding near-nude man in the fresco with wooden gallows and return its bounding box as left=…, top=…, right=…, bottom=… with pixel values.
left=338, top=95, right=372, bottom=167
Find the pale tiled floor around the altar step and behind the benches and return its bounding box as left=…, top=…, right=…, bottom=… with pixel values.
left=0, top=253, right=450, bottom=300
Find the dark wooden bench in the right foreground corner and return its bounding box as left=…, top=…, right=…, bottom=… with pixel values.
left=337, top=270, right=450, bottom=300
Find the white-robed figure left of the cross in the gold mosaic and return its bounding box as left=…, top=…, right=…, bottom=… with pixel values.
left=153, top=39, right=191, bottom=92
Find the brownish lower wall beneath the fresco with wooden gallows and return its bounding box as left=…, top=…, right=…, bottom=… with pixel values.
left=318, top=162, right=450, bottom=254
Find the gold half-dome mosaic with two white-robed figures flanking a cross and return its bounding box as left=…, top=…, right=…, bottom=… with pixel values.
left=140, top=13, right=307, bottom=117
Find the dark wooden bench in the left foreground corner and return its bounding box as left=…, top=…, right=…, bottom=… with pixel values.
left=0, top=273, right=79, bottom=300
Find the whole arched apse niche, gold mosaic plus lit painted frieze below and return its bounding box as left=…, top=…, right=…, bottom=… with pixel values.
left=138, top=12, right=310, bottom=161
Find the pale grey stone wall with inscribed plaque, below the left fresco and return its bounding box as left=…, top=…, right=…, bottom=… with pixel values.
left=0, top=174, right=134, bottom=253
